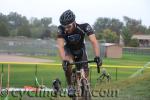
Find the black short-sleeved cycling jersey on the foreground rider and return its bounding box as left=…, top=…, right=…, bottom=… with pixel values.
left=57, top=23, right=94, bottom=50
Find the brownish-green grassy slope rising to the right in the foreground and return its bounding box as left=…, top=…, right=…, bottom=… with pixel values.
left=94, top=73, right=150, bottom=100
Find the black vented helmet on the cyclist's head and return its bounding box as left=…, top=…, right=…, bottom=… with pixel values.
left=59, top=10, right=75, bottom=25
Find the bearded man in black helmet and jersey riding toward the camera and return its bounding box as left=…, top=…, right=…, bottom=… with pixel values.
left=57, top=10, right=102, bottom=95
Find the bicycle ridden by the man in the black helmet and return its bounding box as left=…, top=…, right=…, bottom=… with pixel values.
left=70, top=60, right=100, bottom=100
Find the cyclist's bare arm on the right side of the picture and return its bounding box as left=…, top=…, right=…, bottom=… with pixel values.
left=89, top=34, right=100, bottom=57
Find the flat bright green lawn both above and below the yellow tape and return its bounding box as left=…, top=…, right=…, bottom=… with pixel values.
left=0, top=54, right=150, bottom=87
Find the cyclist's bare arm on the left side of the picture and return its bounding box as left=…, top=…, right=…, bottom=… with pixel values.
left=57, top=38, right=65, bottom=60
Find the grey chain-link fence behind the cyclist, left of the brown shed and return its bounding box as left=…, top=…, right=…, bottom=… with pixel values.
left=0, top=37, right=105, bottom=58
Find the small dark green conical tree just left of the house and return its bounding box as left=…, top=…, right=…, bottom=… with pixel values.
left=121, top=27, right=132, bottom=46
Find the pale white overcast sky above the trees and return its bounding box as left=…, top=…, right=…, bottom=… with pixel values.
left=0, top=0, right=150, bottom=26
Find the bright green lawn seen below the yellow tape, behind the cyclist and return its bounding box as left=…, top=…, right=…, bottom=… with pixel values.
left=3, top=64, right=146, bottom=87
